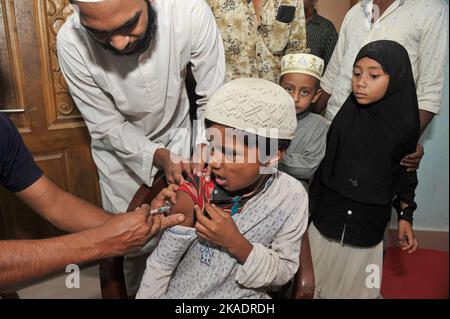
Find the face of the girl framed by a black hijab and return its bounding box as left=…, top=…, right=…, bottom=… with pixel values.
left=352, top=57, right=389, bottom=105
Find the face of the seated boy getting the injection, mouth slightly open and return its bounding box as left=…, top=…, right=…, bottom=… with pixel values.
left=207, top=124, right=281, bottom=194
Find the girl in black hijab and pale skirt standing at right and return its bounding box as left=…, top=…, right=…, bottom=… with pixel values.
left=310, top=40, right=420, bottom=298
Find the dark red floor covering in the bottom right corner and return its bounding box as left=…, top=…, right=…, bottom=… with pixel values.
left=381, top=248, right=449, bottom=299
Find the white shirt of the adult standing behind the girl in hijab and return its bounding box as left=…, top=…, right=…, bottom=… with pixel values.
left=321, top=0, right=448, bottom=121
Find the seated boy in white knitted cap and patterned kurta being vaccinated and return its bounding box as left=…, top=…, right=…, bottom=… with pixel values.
left=137, top=79, right=308, bottom=298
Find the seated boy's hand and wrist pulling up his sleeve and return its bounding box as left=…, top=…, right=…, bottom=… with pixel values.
left=194, top=203, right=253, bottom=264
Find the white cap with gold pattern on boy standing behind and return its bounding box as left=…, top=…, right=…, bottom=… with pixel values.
left=281, top=53, right=325, bottom=81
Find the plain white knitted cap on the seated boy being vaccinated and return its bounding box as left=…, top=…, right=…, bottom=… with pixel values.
left=205, top=78, right=297, bottom=140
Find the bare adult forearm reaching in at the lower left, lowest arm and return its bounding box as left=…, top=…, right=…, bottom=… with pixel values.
left=0, top=232, right=103, bottom=291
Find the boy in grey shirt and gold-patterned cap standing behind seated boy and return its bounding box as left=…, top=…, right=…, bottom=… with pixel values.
left=279, top=53, right=328, bottom=188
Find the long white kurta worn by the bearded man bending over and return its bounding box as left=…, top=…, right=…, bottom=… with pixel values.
left=57, top=0, right=225, bottom=212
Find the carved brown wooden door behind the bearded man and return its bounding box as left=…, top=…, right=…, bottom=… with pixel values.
left=0, top=0, right=101, bottom=239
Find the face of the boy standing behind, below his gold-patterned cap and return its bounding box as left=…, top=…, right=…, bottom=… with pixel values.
left=280, top=73, right=322, bottom=114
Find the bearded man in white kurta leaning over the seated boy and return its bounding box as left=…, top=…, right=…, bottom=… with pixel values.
left=57, top=0, right=225, bottom=295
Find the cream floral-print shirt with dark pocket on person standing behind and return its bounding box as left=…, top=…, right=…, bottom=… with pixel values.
left=206, top=0, right=306, bottom=83
